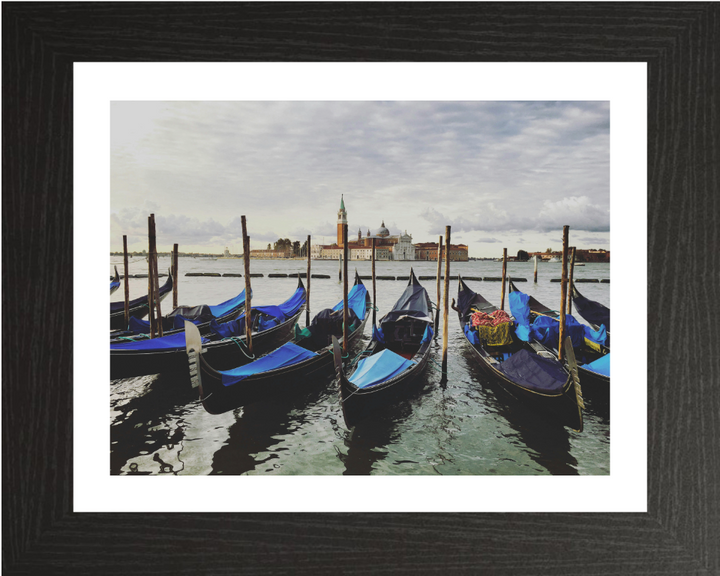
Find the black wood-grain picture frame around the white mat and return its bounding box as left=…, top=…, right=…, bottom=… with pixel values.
left=2, top=2, right=720, bottom=576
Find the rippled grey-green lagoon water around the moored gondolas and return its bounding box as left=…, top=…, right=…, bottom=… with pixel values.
left=110, top=257, right=610, bottom=475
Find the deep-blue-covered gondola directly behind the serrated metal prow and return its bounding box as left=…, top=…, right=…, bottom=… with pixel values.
left=110, top=278, right=307, bottom=380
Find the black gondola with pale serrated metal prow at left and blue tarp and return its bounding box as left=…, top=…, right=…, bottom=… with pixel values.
left=186, top=272, right=371, bottom=414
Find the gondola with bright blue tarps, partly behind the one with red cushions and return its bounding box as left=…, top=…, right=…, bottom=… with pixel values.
left=509, top=281, right=610, bottom=413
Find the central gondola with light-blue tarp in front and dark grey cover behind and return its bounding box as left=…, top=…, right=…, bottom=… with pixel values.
left=333, top=270, right=433, bottom=428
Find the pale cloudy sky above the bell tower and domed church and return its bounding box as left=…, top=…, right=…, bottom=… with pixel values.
left=111, top=102, right=610, bottom=257
